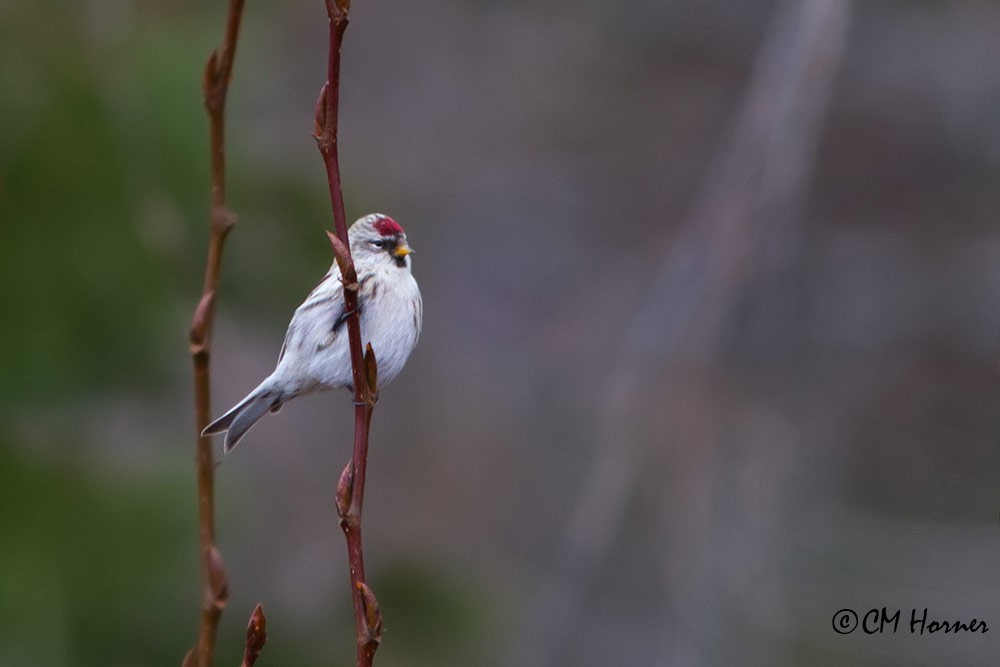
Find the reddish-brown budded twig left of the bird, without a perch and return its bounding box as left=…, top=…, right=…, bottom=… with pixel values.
left=185, top=0, right=243, bottom=667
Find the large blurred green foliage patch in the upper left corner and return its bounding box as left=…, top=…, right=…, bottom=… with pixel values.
left=0, top=3, right=206, bottom=404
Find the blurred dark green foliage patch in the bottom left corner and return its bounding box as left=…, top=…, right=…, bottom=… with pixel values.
left=0, top=442, right=196, bottom=667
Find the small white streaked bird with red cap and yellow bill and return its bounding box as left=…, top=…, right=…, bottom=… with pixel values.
left=202, top=213, right=423, bottom=452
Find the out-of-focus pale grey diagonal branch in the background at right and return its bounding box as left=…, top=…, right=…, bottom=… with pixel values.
left=509, top=0, right=853, bottom=665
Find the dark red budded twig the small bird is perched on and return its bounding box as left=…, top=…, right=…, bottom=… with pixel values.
left=314, top=0, right=382, bottom=667
